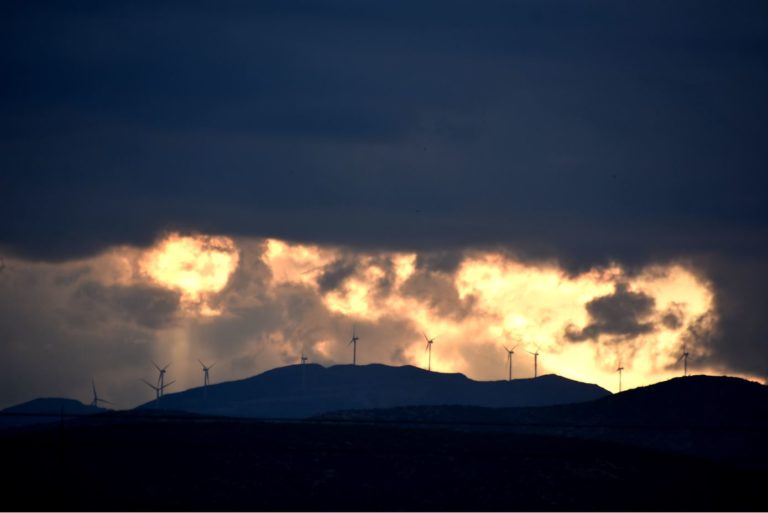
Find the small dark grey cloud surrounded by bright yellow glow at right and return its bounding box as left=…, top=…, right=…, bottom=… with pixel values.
left=565, top=283, right=655, bottom=342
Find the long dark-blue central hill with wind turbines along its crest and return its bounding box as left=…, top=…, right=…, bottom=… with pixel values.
left=135, top=364, right=610, bottom=418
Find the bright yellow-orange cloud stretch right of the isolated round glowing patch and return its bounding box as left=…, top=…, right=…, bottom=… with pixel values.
left=258, top=240, right=728, bottom=389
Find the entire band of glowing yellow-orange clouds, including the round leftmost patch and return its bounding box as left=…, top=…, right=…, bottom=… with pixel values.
left=75, top=234, right=748, bottom=390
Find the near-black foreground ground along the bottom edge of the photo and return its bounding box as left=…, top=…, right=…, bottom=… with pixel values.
left=0, top=417, right=768, bottom=511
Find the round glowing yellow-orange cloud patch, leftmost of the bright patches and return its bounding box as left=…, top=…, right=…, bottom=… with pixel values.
left=139, top=234, right=239, bottom=315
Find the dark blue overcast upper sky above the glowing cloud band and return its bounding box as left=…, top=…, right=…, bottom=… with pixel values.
left=0, top=1, right=768, bottom=380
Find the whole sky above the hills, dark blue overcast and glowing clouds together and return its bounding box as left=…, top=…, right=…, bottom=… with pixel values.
left=0, top=0, right=768, bottom=407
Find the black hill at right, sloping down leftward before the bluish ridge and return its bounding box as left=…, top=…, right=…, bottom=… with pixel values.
left=319, top=376, right=768, bottom=465
